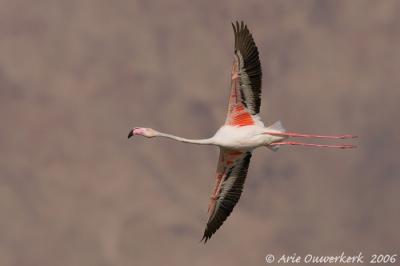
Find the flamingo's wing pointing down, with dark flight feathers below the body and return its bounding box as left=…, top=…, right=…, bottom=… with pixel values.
left=202, top=149, right=251, bottom=243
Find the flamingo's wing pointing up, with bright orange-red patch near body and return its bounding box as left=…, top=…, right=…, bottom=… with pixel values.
left=225, top=21, right=262, bottom=126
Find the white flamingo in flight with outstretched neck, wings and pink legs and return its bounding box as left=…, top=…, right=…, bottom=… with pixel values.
left=128, top=21, right=356, bottom=243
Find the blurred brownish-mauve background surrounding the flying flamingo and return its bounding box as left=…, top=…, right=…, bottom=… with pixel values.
left=0, top=0, right=400, bottom=266
